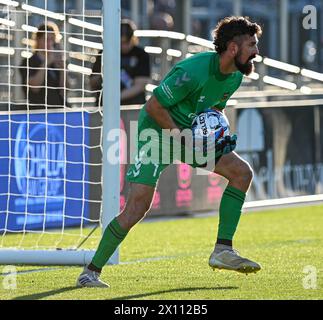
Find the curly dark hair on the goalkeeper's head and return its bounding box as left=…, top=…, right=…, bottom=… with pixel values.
left=212, top=16, right=262, bottom=54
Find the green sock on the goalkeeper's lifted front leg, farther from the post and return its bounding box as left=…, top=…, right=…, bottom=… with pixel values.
left=218, top=186, right=246, bottom=240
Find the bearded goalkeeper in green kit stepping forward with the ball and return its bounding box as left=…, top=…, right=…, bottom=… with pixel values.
left=77, top=17, right=262, bottom=287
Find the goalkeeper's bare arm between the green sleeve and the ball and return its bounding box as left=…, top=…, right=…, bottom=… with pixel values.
left=146, top=96, right=179, bottom=130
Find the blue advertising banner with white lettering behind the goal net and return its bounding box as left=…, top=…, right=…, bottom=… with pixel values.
left=0, top=112, right=90, bottom=233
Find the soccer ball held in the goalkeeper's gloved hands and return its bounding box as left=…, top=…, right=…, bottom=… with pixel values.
left=192, top=110, right=230, bottom=149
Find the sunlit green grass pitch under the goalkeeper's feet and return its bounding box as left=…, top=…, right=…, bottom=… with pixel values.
left=0, top=206, right=323, bottom=300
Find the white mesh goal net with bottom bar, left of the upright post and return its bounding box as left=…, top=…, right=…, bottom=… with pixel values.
left=0, top=0, right=120, bottom=265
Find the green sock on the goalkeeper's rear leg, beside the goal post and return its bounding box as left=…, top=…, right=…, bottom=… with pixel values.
left=91, top=218, right=128, bottom=268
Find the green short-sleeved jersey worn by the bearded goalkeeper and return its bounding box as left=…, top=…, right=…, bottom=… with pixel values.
left=139, top=52, right=243, bottom=129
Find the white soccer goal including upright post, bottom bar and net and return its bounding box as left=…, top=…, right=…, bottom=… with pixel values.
left=0, top=0, right=121, bottom=265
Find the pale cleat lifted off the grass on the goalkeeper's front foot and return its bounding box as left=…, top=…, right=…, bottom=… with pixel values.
left=209, top=250, right=261, bottom=273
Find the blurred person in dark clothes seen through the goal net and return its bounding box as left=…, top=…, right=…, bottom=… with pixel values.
left=20, top=22, right=67, bottom=110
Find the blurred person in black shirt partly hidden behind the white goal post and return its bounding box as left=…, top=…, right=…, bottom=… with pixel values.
left=90, top=19, right=150, bottom=105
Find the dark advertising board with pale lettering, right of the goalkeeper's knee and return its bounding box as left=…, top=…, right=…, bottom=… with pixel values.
left=237, top=107, right=323, bottom=200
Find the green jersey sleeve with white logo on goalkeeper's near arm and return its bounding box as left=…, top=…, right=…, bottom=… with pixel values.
left=153, top=68, right=198, bottom=109
